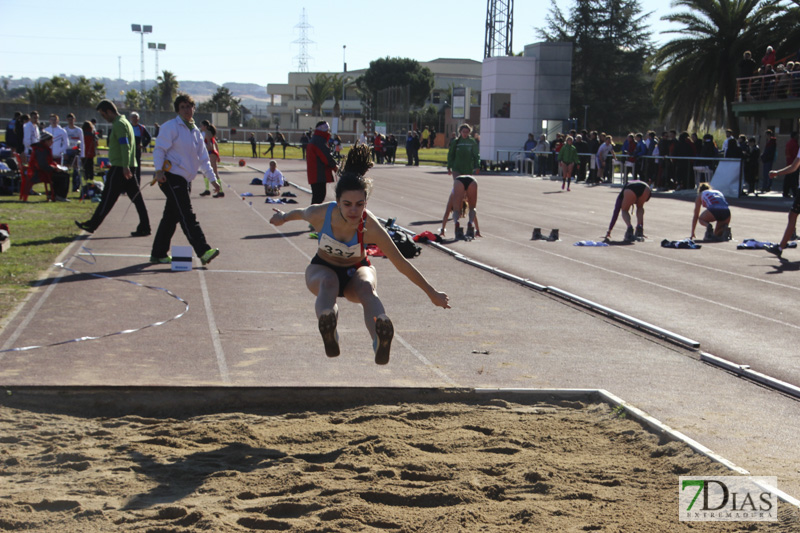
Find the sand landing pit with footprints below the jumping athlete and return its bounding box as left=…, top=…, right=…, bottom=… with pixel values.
left=0, top=389, right=800, bottom=533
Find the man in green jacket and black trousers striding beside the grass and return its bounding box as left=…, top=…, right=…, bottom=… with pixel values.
left=75, top=100, right=150, bottom=237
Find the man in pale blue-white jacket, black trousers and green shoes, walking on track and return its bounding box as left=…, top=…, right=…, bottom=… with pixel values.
left=150, top=94, right=219, bottom=265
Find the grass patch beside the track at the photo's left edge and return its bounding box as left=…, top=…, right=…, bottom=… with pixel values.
left=0, top=192, right=97, bottom=323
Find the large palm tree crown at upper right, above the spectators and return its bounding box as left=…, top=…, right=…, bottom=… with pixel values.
left=651, top=0, right=786, bottom=134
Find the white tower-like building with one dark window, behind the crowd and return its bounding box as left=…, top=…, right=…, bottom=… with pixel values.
left=480, top=43, right=572, bottom=161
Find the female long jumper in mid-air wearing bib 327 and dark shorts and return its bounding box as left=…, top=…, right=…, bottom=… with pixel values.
left=270, top=145, right=450, bottom=365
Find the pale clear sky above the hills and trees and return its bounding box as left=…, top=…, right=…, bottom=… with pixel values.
left=0, top=0, right=671, bottom=85
